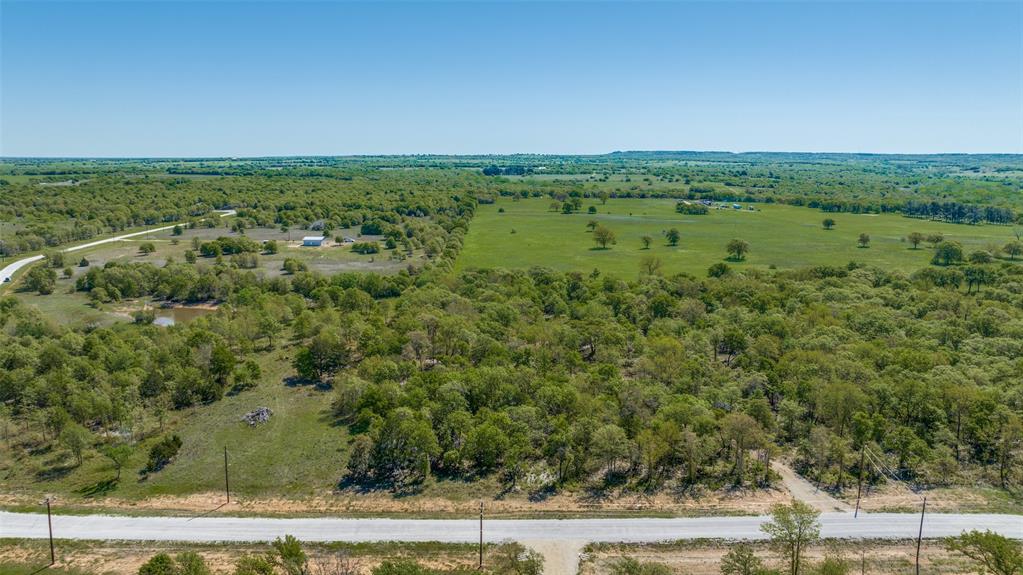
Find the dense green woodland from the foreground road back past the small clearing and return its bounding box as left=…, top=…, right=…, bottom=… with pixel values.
left=0, top=156, right=1023, bottom=501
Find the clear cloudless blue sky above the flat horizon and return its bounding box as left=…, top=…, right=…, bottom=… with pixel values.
left=0, top=0, right=1023, bottom=157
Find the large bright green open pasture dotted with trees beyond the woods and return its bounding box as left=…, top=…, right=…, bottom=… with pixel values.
left=457, top=198, right=1015, bottom=277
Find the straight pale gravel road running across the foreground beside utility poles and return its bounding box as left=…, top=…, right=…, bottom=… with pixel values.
left=0, top=512, right=1023, bottom=543
